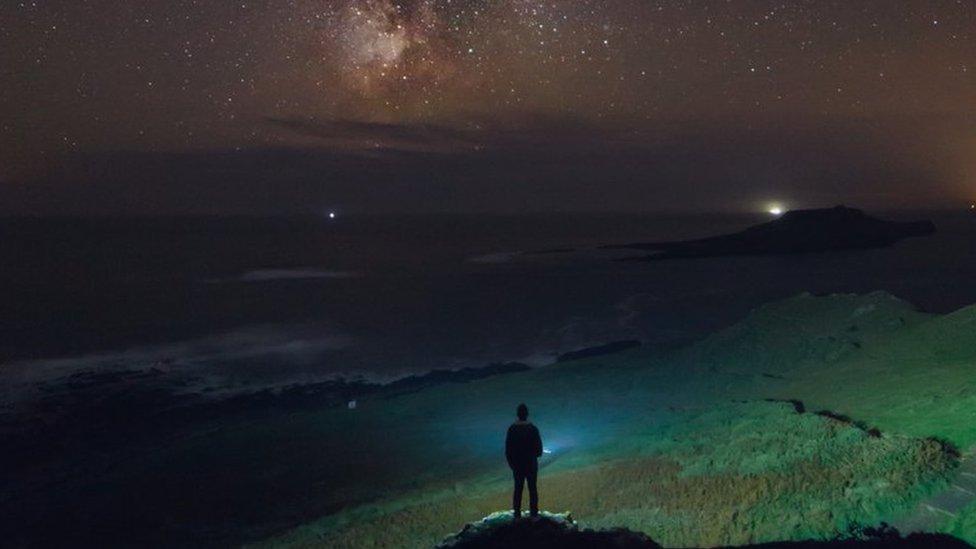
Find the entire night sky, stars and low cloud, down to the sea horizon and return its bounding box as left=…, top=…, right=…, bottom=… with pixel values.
left=0, top=0, right=976, bottom=214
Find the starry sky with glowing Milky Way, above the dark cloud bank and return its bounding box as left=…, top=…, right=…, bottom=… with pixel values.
left=0, top=0, right=976, bottom=212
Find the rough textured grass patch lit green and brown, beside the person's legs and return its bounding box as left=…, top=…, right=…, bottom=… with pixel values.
left=258, top=403, right=954, bottom=547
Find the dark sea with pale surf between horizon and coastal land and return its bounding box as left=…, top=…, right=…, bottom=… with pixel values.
left=0, top=212, right=976, bottom=399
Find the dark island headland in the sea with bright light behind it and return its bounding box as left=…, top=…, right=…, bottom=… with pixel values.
left=605, top=206, right=935, bottom=261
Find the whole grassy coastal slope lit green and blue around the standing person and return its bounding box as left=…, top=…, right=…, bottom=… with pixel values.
left=254, top=293, right=976, bottom=547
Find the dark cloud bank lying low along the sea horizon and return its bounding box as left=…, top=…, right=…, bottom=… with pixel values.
left=0, top=115, right=976, bottom=214
